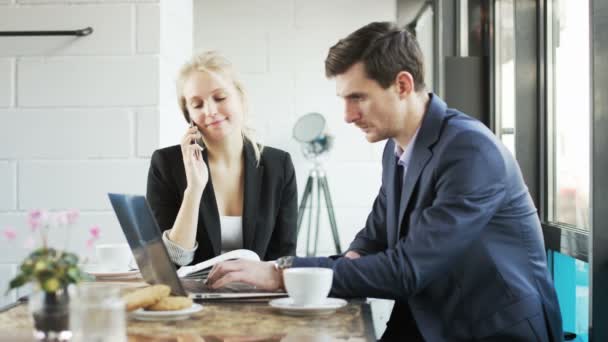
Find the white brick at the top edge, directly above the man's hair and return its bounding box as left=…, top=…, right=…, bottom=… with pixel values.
left=295, top=0, right=397, bottom=31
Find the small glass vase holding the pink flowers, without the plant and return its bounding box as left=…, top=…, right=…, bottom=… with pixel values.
left=28, top=289, right=72, bottom=341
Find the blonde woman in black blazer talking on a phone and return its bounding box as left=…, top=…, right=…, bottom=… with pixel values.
left=147, top=52, right=297, bottom=265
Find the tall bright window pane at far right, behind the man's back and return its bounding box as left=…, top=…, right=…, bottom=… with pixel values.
left=547, top=0, right=591, bottom=229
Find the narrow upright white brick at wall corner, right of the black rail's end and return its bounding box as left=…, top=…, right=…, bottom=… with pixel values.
left=136, top=4, right=160, bottom=54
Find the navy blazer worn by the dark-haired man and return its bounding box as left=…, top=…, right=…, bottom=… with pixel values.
left=294, top=94, right=562, bottom=341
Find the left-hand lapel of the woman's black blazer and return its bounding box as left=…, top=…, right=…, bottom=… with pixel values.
left=197, top=150, right=222, bottom=256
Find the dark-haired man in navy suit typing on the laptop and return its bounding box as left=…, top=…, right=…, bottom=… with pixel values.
left=209, top=23, right=562, bottom=341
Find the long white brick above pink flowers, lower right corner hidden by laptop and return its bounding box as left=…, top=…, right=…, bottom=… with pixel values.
left=18, top=160, right=150, bottom=210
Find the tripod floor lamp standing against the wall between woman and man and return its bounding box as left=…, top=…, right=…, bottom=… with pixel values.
left=293, top=113, right=342, bottom=256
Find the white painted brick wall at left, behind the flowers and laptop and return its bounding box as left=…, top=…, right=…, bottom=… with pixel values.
left=0, top=0, right=160, bottom=303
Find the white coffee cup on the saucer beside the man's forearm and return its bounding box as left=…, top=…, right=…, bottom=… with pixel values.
left=283, top=267, right=334, bottom=306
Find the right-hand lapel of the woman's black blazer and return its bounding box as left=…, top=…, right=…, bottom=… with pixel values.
left=243, top=141, right=264, bottom=252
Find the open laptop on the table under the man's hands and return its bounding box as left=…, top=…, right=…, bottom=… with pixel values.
left=108, top=193, right=287, bottom=301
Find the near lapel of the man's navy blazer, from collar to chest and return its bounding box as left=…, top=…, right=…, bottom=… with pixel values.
left=397, top=94, right=447, bottom=239
